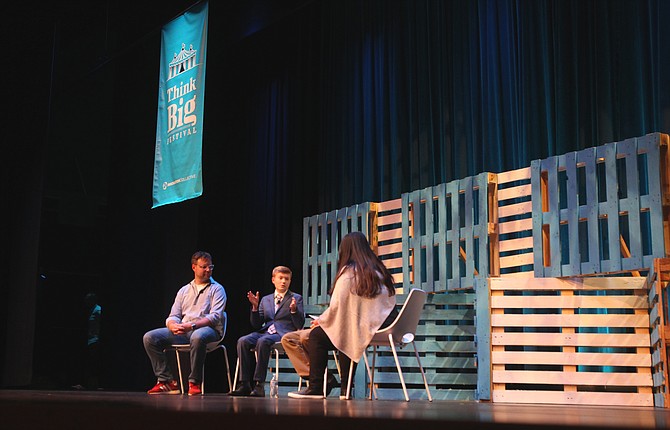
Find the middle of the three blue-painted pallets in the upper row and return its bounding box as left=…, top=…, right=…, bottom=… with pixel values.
left=401, top=173, right=495, bottom=292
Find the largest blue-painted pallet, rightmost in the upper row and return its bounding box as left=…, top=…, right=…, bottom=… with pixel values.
left=531, top=133, right=668, bottom=277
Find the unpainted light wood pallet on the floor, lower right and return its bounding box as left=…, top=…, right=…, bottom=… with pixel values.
left=489, top=277, right=654, bottom=406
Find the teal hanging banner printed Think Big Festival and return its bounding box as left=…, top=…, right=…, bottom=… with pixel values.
left=152, top=2, right=209, bottom=208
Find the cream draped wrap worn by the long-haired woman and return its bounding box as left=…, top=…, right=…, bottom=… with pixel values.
left=319, top=267, right=395, bottom=363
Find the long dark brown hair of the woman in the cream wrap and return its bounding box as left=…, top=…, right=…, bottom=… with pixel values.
left=329, top=231, right=395, bottom=298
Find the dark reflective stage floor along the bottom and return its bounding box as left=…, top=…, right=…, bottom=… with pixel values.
left=0, top=390, right=670, bottom=430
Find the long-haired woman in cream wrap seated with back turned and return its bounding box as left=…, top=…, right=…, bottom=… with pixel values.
left=289, top=232, right=397, bottom=398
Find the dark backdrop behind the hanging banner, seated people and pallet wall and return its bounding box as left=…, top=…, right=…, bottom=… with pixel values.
left=0, top=0, right=670, bottom=390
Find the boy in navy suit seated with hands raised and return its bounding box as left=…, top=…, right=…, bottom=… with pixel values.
left=230, top=266, right=305, bottom=397
